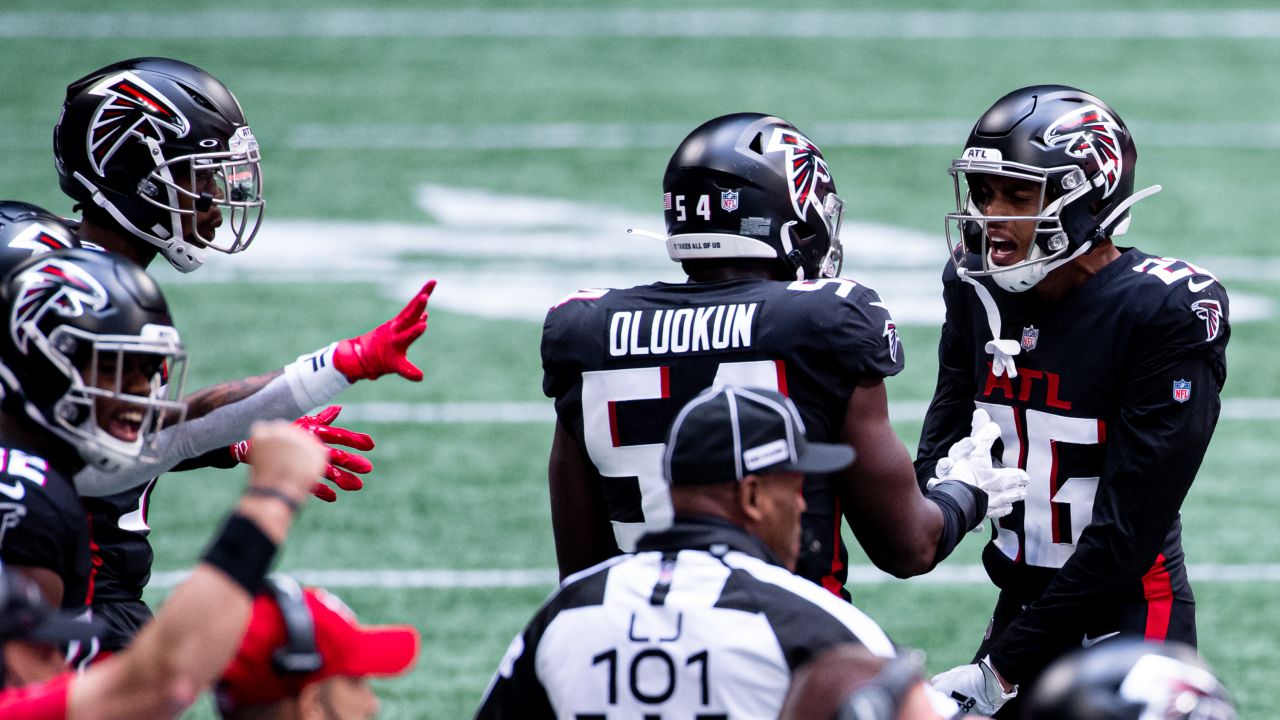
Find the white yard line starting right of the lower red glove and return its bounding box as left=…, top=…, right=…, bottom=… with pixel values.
left=342, top=397, right=1280, bottom=424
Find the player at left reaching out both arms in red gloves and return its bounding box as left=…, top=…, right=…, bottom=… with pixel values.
left=42, top=58, right=434, bottom=648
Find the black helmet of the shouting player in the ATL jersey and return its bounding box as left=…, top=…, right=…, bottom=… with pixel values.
left=946, top=85, right=1160, bottom=292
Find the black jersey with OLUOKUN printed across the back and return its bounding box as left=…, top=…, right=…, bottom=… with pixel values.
left=541, top=278, right=902, bottom=592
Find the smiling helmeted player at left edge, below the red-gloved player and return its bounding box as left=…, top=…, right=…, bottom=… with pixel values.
left=0, top=249, right=186, bottom=609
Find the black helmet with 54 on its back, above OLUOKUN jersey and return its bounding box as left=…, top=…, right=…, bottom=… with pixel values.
left=662, top=113, right=845, bottom=279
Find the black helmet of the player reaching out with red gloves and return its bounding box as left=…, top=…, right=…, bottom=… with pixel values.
left=54, top=58, right=262, bottom=273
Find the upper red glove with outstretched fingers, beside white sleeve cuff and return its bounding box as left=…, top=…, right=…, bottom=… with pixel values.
left=333, top=281, right=435, bottom=382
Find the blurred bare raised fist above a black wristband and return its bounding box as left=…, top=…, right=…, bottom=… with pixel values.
left=246, top=420, right=325, bottom=505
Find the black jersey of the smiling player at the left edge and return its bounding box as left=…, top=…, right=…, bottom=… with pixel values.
left=0, top=439, right=92, bottom=610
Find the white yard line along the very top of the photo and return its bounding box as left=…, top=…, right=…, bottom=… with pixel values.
left=0, top=6, right=1280, bottom=40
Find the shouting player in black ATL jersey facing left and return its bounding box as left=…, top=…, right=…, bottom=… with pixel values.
left=916, top=86, right=1231, bottom=716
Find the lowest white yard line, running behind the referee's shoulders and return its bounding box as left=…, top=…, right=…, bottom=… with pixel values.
left=147, top=562, right=1280, bottom=589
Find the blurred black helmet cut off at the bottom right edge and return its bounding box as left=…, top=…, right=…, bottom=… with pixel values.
left=1023, top=638, right=1236, bottom=720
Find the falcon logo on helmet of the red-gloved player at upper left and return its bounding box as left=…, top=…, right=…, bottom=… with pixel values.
left=88, top=70, right=191, bottom=177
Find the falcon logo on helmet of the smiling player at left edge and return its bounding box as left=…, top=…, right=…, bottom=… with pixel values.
left=9, top=259, right=110, bottom=354
